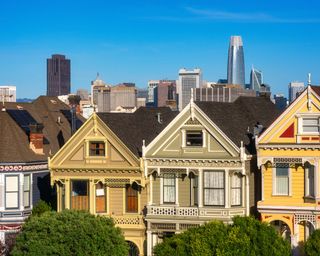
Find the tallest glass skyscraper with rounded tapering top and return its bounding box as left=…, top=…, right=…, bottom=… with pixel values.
left=228, top=36, right=245, bottom=87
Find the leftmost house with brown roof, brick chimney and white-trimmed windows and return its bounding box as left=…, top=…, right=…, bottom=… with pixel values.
left=0, top=96, right=81, bottom=243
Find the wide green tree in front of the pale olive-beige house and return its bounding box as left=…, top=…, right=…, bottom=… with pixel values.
left=154, top=217, right=291, bottom=256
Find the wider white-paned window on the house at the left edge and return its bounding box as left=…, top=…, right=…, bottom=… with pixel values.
left=5, top=175, right=19, bottom=209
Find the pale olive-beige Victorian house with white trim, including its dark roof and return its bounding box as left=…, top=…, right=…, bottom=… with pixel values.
left=142, top=97, right=278, bottom=255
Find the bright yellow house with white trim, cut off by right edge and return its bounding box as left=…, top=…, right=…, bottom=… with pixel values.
left=257, top=85, right=320, bottom=247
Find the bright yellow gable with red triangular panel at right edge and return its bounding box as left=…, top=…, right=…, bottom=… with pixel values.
left=258, top=87, right=320, bottom=144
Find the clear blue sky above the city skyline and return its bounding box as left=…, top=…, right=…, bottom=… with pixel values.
left=0, top=0, right=320, bottom=98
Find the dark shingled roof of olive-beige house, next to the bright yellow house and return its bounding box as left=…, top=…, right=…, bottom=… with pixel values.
left=196, top=96, right=281, bottom=153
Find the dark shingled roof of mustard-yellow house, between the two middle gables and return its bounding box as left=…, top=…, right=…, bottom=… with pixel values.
left=98, top=107, right=179, bottom=157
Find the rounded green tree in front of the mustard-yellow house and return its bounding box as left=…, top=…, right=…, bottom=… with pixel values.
left=11, top=210, right=128, bottom=256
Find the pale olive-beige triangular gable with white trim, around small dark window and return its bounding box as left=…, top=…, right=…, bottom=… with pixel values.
left=144, top=102, right=239, bottom=159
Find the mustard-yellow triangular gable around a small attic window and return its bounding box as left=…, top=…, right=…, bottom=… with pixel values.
left=50, top=114, right=139, bottom=169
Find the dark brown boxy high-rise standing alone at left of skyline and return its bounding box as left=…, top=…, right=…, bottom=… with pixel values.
left=47, top=54, right=70, bottom=96
